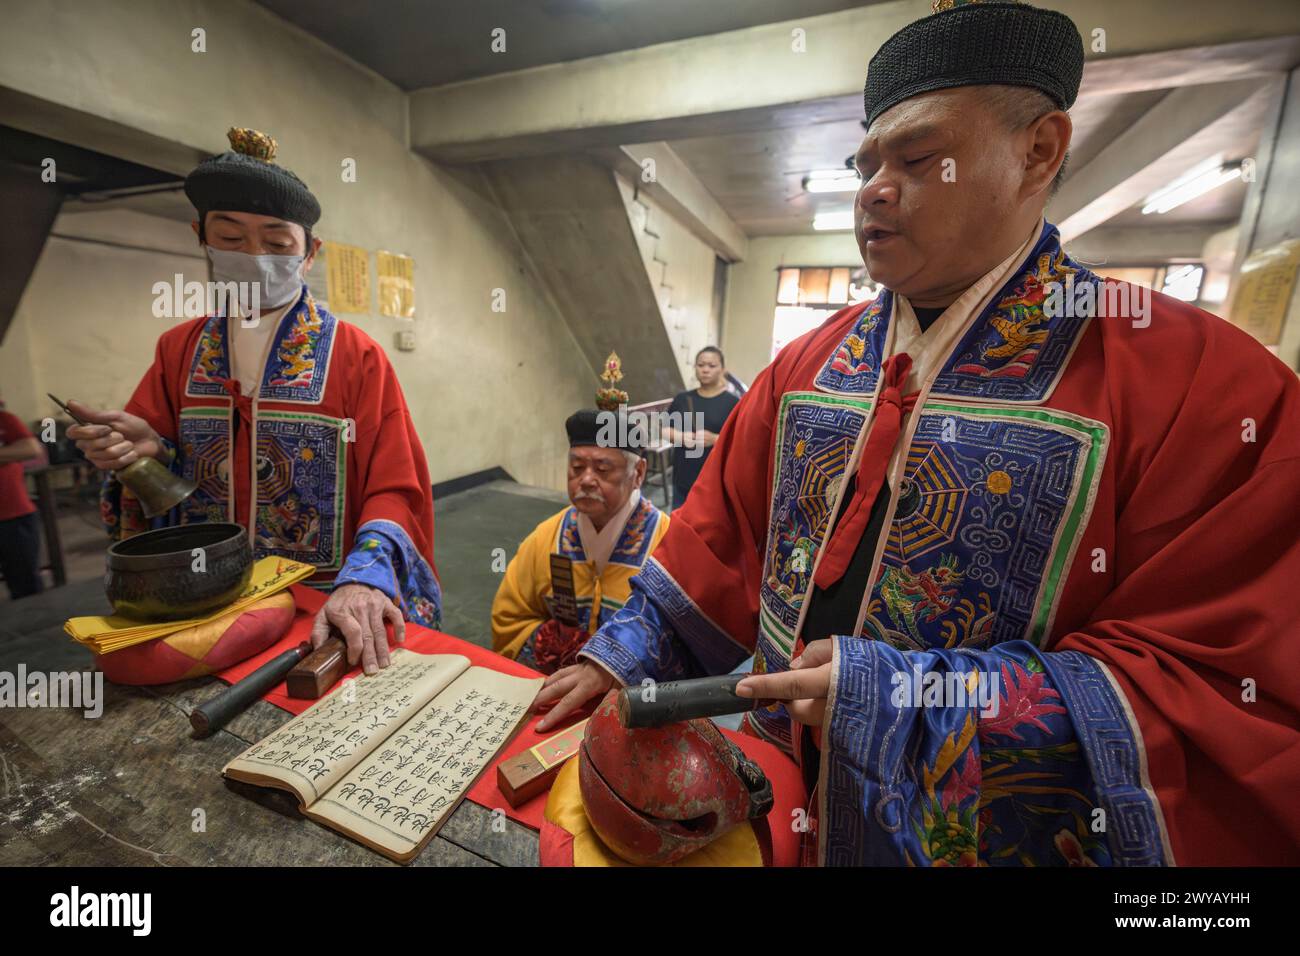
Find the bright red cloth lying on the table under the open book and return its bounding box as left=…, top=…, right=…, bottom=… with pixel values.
left=216, top=584, right=579, bottom=830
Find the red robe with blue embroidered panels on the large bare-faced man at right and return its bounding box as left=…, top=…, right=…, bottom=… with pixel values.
left=581, top=225, right=1300, bottom=865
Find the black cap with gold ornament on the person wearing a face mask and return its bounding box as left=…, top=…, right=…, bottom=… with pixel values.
left=185, top=129, right=321, bottom=229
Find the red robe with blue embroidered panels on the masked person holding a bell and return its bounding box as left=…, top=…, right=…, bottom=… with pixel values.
left=104, top=286, right=441, bottom=627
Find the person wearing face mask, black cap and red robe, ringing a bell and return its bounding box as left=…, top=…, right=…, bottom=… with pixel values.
left=69, top=129, right=442, bottom=672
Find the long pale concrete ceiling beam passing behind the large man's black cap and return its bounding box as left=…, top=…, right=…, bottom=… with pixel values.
left=408, top=0, right=1300, bottom=163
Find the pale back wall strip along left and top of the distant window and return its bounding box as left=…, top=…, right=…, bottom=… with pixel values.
left=720, top=232, right=862, bottom=382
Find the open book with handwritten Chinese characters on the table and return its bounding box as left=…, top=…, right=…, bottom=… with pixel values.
left=221, top=648, right=542, bottom=864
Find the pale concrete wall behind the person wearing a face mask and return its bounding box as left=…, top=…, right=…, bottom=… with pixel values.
left=0, top=0, right=595, bottom=488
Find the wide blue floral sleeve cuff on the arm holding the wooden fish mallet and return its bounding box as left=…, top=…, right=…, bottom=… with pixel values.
left=819, top=637, right=1158, bottom=866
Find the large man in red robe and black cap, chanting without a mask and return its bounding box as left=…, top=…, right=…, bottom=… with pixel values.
left=540, top=1, right=1300, bottom=865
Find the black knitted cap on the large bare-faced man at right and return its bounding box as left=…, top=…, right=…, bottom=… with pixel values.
left=862, top=3, right=1083, bottom=129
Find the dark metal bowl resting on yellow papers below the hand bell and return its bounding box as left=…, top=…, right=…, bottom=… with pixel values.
left=104, top=522, right=252, bottom=620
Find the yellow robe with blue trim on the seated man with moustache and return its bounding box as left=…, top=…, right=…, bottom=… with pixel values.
left=491, top=498, right=668, bottom=658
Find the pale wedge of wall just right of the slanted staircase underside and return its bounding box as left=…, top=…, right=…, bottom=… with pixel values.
left=616, top=176, right=722, bottom=392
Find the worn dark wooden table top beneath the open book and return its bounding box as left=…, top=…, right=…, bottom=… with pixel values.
left=0, top=580, right=538, bottom=866
